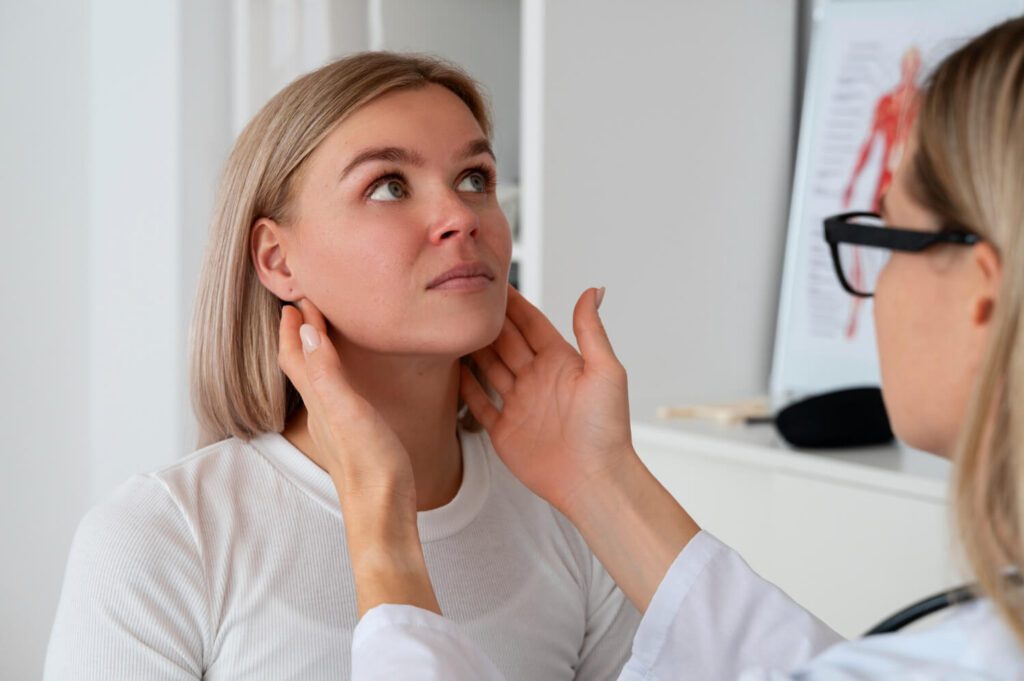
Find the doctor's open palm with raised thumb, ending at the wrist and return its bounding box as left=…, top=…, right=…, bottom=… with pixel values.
left=462, top=287, right=635, bottom=515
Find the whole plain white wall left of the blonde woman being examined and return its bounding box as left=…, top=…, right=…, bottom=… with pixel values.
left=0, top=0, right=230, bottom=679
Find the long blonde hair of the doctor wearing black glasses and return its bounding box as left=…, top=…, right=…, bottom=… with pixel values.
left=910, top=17, right=1024, bottom=643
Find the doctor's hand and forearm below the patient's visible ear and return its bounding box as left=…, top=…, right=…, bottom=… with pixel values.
left=278, top=299, right=440, bottom=616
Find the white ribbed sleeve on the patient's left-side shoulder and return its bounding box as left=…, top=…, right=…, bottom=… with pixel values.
left=44, top=476, right=208, bottom=681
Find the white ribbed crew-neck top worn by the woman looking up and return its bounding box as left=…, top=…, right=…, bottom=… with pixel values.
left=45, top=431, right=639, bottom=681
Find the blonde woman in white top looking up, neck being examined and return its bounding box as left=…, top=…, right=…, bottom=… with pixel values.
left=46, top=53, right=639, bottom=681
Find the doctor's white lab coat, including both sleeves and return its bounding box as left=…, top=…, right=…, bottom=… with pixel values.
left=352, top=531, right=1024, bottom=681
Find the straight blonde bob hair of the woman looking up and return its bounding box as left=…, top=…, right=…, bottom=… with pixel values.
left=189, top=52, right=492, bottom=448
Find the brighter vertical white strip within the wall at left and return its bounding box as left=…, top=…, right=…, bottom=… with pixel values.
left=88, top=0, right=183, bottom=496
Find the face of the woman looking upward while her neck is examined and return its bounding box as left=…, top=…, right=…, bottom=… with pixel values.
left=272, top=85, right=512, bottom=357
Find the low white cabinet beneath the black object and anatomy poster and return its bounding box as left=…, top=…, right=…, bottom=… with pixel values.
left=633, top=424, right=963, bottom=637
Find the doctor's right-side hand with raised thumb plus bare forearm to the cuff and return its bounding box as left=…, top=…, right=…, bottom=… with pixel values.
left=461, top=287, right=699, bottom=612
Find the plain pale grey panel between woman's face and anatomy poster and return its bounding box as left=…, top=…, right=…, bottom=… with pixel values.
left=536, top=0, right=798, bottom=420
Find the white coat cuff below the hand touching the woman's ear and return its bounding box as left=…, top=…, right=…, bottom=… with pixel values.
left=352, top=605, right=503, bottom=681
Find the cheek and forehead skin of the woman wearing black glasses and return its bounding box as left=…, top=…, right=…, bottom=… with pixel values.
left=874, top=137, right=992, bottom=457
